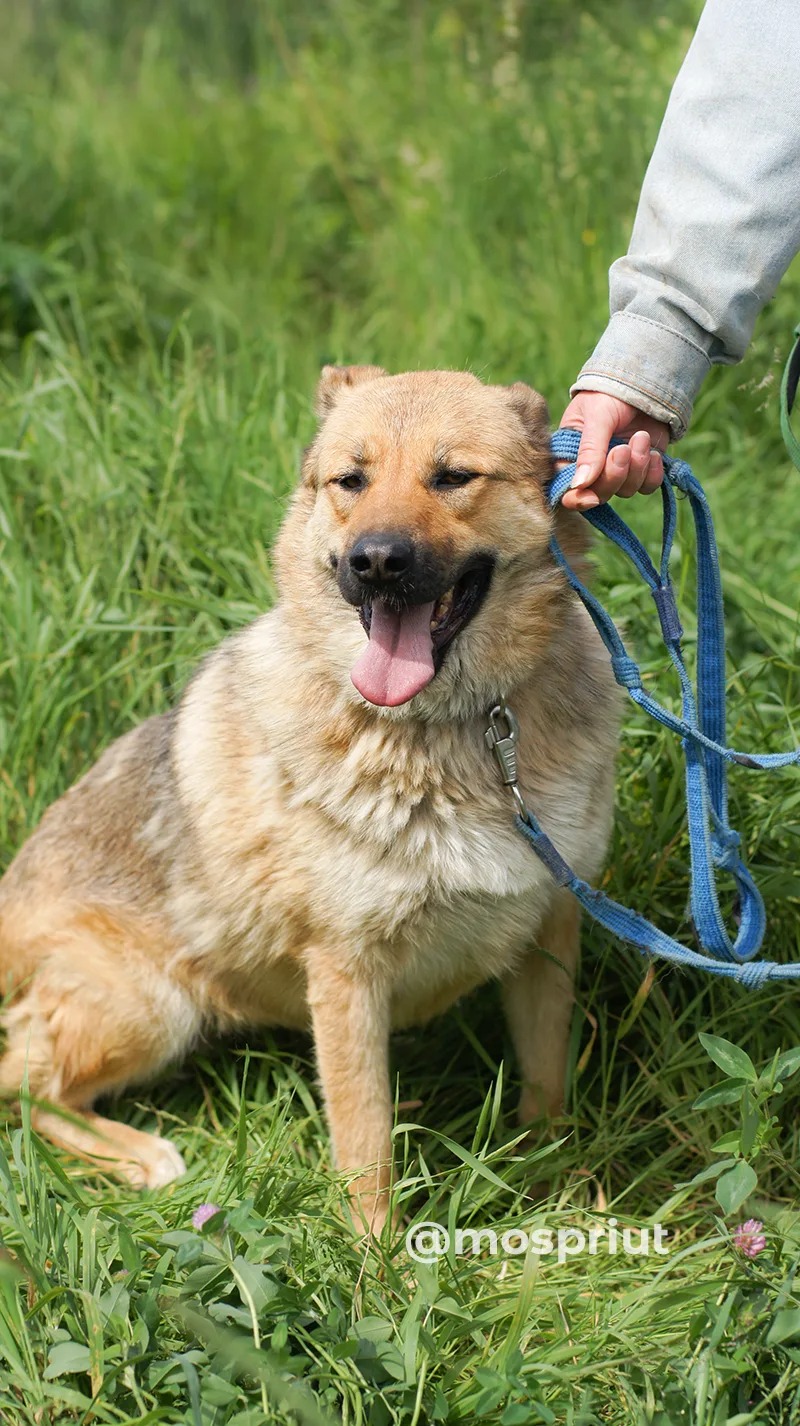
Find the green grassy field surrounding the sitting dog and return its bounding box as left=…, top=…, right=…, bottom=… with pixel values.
left=0, top=0, right=800, bottom=1426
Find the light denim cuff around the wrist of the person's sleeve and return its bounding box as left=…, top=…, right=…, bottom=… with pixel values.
left=570, top=312, right=712, bottom=441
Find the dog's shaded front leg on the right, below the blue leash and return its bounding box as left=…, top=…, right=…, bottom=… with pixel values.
left=503, top=891, right=580, bottom=1124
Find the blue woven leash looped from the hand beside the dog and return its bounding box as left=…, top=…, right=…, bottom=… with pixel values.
left=488, top=429, right=800, bottom=988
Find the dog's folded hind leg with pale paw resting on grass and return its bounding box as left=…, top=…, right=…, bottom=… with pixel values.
left=0, top=907, right=200, bottom=1188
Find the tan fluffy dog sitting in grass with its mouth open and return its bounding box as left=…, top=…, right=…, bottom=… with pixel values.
left=0, top=366, right=619, bottom=1224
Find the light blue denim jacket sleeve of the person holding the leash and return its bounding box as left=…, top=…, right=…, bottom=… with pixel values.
left=572, top=0, right=800, bottom=439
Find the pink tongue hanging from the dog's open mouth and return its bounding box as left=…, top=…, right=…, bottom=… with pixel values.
left=349, top=599, right=435, bottom=709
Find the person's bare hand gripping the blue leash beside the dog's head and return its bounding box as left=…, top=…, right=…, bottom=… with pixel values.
left=560, top=391, right=669, bottom=511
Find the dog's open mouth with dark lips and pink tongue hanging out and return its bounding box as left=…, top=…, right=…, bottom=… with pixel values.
left=351, top=556, right=493, bottom=707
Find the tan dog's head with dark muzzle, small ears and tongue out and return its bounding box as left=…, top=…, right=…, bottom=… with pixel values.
left=278, top=366, right=582, bottom=716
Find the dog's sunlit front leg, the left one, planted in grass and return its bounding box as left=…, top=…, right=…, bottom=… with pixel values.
left=307, top=951, right=392, bottom=1233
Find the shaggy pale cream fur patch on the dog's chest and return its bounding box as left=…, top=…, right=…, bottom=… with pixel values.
left=283, top=724, right=552, bottom=1020
